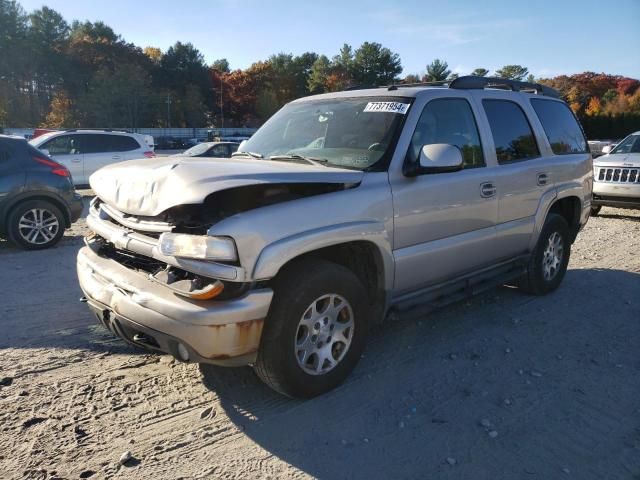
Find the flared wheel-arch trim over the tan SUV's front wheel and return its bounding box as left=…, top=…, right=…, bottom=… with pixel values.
left=252, top=221, right=394, bottom=291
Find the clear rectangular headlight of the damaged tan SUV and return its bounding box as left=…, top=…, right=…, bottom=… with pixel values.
left=160, top=233, right=238, bottom=262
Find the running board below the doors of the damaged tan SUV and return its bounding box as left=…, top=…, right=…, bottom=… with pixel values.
left=390, top=255, right=529, bottom=316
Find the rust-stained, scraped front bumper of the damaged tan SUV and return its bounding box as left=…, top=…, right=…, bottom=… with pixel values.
left=77, top=247, right=273, bottom=365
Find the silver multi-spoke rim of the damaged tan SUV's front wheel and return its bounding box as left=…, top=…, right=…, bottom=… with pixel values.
left=295, top=293, right=354, bottom=375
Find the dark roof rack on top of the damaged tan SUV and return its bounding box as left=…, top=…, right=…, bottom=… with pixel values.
left=385, top=75, right=560, bottom=98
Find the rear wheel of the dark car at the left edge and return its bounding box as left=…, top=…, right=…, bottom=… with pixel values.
left=7, top=200, right=65, bottom=250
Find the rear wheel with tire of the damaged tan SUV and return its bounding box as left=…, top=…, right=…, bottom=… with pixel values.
left=518, top=213, right=571, bottom=295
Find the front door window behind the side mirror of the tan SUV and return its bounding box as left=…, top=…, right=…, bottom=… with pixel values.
left=409, top=98, right=484, bottom=168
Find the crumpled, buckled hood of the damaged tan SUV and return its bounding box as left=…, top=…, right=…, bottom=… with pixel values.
left=89, top=157, right=364, bottom=217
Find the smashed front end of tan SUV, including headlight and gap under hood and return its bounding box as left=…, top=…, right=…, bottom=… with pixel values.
left=78, top=174, right=352, bottom=366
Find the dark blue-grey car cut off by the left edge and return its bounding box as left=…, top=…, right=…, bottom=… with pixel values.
left=0, top=135, right=82, bottom=250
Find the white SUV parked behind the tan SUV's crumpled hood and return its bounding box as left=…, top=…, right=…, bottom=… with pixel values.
left=29, top=130, right=155, bottom=185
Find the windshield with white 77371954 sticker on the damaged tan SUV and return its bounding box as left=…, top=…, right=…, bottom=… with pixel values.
left=236, top=97, right=411, bottom=170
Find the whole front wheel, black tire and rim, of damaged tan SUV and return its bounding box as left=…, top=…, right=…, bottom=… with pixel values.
left=255, top=258, right=369, bottom=398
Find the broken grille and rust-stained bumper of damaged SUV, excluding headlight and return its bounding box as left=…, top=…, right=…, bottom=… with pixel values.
left=78, top=193, right=273, bottom=365
